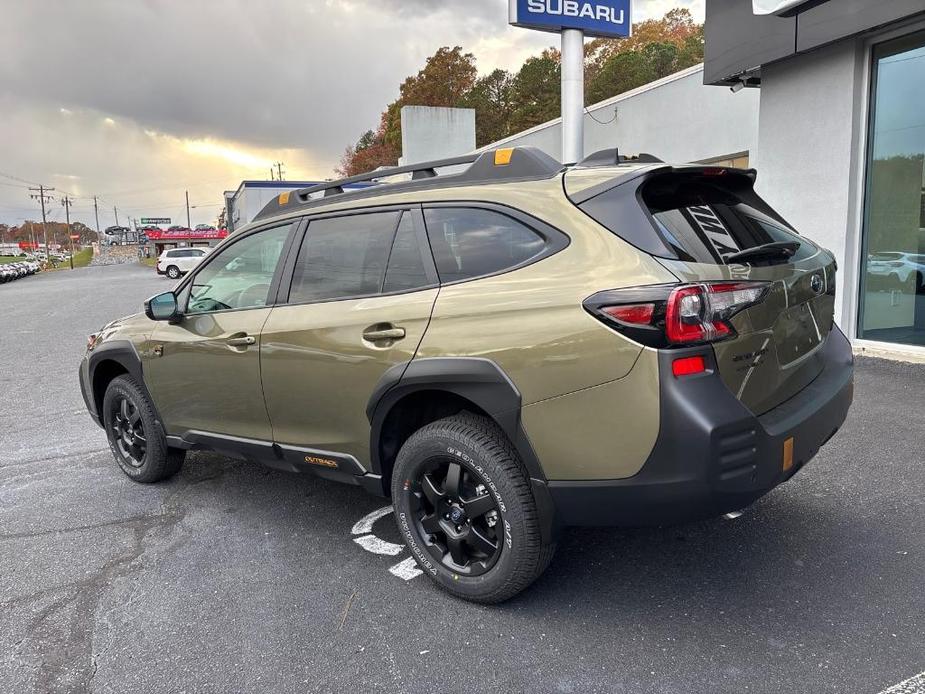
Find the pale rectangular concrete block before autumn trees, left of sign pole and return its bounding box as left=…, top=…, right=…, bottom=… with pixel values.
left=401, top=106, right=475, bottom=164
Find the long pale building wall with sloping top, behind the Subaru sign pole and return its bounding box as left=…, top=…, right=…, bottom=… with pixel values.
left=483, top=65, right=760, bottom=162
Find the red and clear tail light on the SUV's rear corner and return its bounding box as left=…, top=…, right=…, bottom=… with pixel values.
left=584, top=282, right=770, bottom=348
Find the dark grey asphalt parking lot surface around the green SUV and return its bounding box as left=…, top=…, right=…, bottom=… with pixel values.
left=0, top=265, right=925, bottom=694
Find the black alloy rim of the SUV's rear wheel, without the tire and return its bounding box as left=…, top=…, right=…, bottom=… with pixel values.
left=407, top=458, right=504, bottom=577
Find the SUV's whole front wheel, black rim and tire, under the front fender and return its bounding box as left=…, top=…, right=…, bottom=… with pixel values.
left=102, top=376, right=186, bottom=483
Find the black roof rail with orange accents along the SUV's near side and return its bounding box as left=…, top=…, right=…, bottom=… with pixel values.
left=254, top=147, right=563, bottom=220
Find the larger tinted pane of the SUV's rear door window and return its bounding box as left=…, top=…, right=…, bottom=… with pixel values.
left=289, top=212, right=401, bottom=303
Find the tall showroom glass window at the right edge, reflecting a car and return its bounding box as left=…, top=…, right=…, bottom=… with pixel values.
left=858, top=34, right=925, bottom=346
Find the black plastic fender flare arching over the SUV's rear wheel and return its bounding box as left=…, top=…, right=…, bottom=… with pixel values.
left=366, top=357, right=556, bottom=537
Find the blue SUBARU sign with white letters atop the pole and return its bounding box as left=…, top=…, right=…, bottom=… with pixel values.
left=510, top=0, right=633, bottom=38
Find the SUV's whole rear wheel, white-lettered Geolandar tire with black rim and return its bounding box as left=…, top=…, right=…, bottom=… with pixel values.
left=391, top=412, right=556, bottom=604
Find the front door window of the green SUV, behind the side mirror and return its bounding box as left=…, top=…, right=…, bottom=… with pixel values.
left=187, top=224, right=292, bottom=313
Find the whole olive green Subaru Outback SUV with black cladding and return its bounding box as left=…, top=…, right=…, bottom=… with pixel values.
left=80, top=148, right=853, bottom=602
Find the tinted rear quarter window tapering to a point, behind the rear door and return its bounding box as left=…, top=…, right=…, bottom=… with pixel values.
left=424, top=208, right=546, bottom=282
